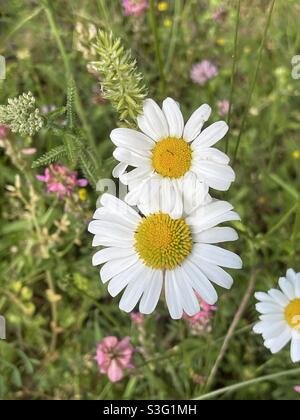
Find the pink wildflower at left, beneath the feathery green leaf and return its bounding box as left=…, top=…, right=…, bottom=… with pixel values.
left=36, top=164, right=88, bottom=199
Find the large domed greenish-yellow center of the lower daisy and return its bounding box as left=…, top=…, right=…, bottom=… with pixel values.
left=135, top=213, right=193, bottom=270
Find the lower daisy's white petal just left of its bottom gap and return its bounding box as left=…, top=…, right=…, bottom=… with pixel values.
left=139, top=270, right=163, bottom=314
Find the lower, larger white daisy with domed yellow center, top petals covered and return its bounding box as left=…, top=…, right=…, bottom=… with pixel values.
left=88, top=194, right=242, bottom=319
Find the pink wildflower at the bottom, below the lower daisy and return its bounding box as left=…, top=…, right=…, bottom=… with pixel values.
left=96, top=336, right=133, bottom=382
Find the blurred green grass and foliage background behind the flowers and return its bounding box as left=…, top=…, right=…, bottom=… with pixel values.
left=0, top=0, right=300, bottom=399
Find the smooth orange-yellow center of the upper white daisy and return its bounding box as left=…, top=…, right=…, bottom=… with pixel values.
left=152, top=137, right=192, bottom=178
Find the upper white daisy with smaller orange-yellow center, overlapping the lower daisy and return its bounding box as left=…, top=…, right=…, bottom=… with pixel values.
left=110, top=98, right=235, bottom=217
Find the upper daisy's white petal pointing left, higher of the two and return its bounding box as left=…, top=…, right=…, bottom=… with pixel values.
left=110, top=128, right=155, bottom=152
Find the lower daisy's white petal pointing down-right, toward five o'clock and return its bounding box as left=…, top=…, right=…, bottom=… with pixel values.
left=182, top=259, right=218, bottom=305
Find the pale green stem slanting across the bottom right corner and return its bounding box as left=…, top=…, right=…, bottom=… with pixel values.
left=194, top=368, right=300, bottom=401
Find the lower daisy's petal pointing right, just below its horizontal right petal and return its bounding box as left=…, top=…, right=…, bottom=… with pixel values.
left=193, top=244, right=243, bottom=269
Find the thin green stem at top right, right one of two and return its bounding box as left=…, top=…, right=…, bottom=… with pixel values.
left=232, top=0, right=276, bottom=166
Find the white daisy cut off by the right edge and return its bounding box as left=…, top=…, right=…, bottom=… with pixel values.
left=254, top=269, right=300, bottom=363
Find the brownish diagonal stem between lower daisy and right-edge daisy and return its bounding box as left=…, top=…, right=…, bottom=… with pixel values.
left=206, top=269, right=258, bottom=390
